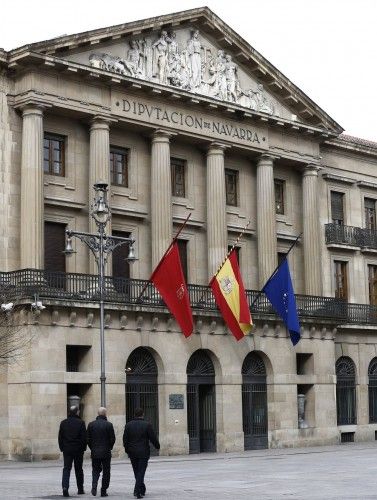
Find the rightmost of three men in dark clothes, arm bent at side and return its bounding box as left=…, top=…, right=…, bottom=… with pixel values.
left=123, top=408, right=160, bottom=498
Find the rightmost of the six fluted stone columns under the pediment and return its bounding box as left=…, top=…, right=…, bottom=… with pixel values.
left=302, top=165, right=322, bottom=295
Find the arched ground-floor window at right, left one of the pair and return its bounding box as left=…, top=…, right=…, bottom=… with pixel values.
left=335, top=356, right=356, bottom=425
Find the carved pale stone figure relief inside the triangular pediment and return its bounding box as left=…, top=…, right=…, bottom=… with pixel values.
left=89, top=29, right=278, bottom=115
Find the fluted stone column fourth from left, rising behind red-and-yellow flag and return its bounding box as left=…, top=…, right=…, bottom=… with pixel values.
left=207, top=142, right=228, bottom=278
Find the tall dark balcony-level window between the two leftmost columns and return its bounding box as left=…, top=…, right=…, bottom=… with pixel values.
left=44, top=222, right=66, bottom=273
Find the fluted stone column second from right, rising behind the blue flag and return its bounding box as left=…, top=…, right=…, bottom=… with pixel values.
left=257, top=154, right=277, bottom=287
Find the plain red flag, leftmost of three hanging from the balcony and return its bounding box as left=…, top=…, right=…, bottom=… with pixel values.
left=150, top=243, right=194, bottom=337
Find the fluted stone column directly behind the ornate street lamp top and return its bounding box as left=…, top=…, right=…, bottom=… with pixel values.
left=88, top=116, right=111, bottom=274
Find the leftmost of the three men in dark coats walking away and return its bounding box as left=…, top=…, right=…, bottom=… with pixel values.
left=59, top=406, right=86, bottom=497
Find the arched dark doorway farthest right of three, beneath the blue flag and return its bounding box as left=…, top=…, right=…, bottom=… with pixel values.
left=242, top=352, right=268, bottom=450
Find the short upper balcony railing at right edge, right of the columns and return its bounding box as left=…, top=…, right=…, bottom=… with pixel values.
left=325, top=224, right=377, bottom=249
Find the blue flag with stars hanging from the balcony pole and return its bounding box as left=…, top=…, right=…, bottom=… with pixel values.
left=262, top=259, right=300, bottom=345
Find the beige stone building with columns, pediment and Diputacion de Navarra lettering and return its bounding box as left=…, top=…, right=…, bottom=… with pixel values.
left=0, top=8, right=377, bottom=459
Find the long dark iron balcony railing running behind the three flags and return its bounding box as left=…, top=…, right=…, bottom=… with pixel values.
left=0, top=269, right=377, bottom=325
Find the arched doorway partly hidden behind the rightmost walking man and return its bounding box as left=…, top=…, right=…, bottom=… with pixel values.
left=126, top=347, right=158, bottom=452
